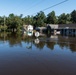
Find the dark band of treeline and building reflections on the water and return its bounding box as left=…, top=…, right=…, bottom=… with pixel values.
left=0, top=33, right=76, bottom=52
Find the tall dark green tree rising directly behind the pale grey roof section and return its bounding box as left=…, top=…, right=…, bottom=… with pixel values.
left=47, top=11, right=57, bottom=24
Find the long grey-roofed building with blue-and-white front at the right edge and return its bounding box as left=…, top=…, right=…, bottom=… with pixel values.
left=48, top=24, right=76, bottom=35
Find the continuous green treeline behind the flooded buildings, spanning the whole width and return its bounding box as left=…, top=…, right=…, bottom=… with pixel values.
left=0, top=10, right=76, bottom=31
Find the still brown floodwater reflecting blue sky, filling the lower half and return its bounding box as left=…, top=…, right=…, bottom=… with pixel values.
left=0, top=33, right=76, bottom=75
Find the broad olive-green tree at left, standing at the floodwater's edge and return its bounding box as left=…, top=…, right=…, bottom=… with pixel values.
left=7, top=14, right=22, bottom=32
